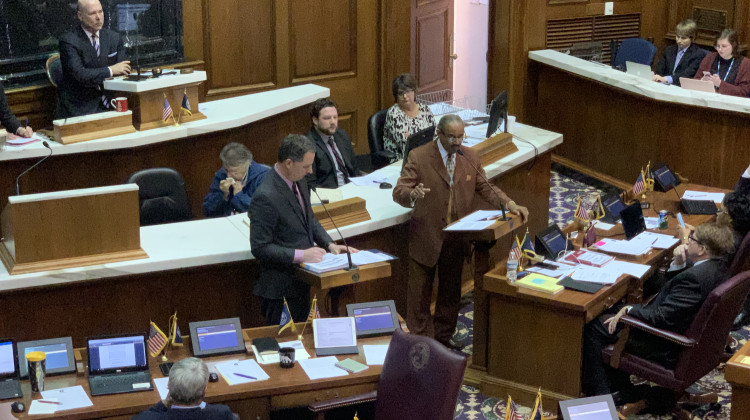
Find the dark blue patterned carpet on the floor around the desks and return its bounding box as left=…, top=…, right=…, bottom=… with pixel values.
left=453, top=164, right=750, bottom=420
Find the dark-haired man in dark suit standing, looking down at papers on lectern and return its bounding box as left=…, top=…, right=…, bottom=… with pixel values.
left=248, top=134, right=357, bottom=325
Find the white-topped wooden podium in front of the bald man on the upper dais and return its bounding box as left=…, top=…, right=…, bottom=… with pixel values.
left=104, top=70, right=206, bottom=131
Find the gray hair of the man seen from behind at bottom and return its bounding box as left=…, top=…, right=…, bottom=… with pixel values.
left=168, top=357, right=208, bottom=405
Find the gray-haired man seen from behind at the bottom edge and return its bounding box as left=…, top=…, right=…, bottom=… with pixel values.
left=133, top=357, right=234, bottom=420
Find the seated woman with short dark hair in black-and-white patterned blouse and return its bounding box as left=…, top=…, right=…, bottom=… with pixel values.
left=383, top=73, right=435, bottom=161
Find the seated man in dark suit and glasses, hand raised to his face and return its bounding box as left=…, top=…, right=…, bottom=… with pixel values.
left=581, top=222, right=734, bottom=410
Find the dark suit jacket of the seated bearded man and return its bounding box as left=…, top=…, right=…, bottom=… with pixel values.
left=307, top=128, right=359, bottom=188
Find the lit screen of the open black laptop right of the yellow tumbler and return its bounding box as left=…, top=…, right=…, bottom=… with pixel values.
left=88, top=335, right=148, bottom=373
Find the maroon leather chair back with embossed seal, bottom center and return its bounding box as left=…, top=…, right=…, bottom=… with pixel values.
left=375, top=329, right=466, bottom=420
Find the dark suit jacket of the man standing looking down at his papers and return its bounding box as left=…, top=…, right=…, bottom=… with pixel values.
left=248, top=168, right=333, bottom=299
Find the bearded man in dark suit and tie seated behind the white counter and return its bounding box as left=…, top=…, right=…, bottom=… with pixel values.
left=307, top=98, right=360, bottom=188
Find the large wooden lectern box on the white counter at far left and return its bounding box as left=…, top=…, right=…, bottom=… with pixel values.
left=0, top=184, right=148, bottom=274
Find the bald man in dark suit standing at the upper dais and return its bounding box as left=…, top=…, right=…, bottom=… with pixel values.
left=60, top=0, right=130, bottom=118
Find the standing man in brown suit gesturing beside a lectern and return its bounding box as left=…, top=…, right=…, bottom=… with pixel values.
left=393, top=115, right=529, bottom=348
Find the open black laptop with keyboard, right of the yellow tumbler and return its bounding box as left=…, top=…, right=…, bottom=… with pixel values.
left=87, top=334, right=154, bottom=396
